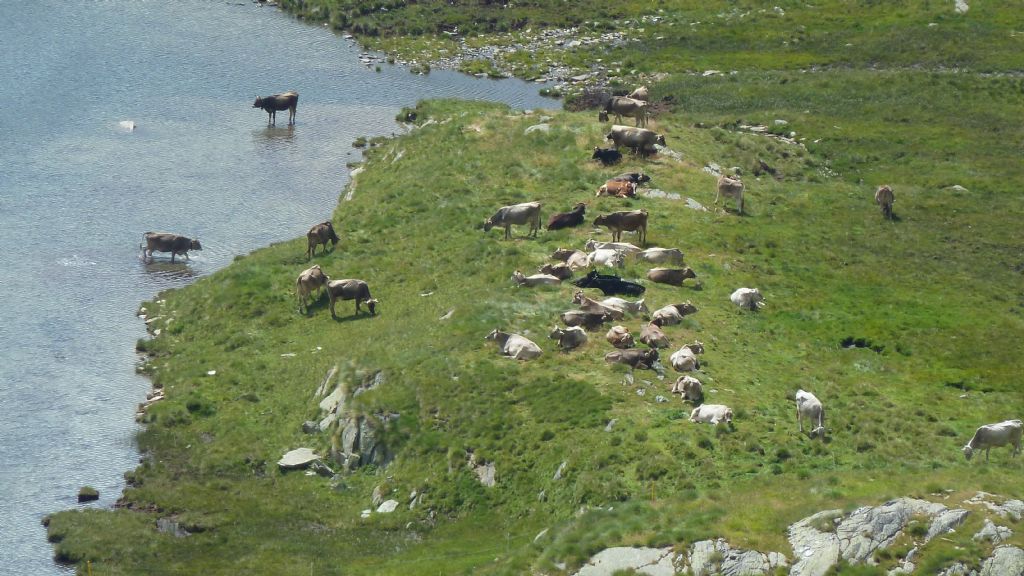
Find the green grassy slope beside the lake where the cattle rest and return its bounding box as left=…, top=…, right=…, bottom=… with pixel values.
left=48, top=2, right=1024, bottom=575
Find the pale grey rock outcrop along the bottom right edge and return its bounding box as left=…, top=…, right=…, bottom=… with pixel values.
left=577, top=492, right=1024, bottom=576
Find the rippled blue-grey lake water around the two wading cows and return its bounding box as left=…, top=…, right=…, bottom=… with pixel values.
left=0, top=0, right=560, bottom=575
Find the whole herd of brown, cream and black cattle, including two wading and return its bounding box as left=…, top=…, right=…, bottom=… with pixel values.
left=142, top=87, right=1022, bottom=460
